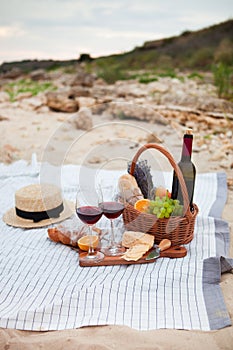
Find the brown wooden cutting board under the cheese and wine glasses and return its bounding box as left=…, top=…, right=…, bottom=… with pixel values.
left=79, top=246, right=187, bottom=267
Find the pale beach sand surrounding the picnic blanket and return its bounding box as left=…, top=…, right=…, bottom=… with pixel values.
left=0, top=106, right=233, bottom=350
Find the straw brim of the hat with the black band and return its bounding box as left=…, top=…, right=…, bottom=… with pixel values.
left=3, top=200, right=75, bottom=228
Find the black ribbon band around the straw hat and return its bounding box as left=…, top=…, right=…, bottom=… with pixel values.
left=15, top=203, right=64, bottom=222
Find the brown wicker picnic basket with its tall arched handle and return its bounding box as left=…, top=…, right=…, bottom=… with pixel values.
left=123, top=143, right=198, bottom=246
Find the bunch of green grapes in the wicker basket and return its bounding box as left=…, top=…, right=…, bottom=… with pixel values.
left=149, top=196, right=183, bottom=219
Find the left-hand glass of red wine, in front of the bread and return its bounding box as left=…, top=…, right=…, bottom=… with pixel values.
left=76, top=187, right=104, bottom=263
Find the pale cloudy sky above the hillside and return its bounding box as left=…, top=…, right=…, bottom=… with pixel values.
left=0, top=0, right=233, bottom=64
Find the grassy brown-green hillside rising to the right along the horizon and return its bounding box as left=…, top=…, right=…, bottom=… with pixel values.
left=0, top=19, right=233, bottom=98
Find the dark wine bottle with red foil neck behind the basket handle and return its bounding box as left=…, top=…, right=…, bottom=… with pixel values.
left=171, top=129, right=196, bottom=210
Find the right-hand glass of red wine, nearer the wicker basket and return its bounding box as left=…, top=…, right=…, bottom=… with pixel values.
left=99, top=187, right=125, bottom=256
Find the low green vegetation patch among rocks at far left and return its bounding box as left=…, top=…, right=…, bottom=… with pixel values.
left=4, top=79, right=56, bottom=102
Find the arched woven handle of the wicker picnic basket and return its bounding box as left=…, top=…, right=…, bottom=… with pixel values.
left=130, top=143, right=189, bottom=214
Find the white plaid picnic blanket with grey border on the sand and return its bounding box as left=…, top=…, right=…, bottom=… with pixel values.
left=0, top=161, right=233, bottom=331
